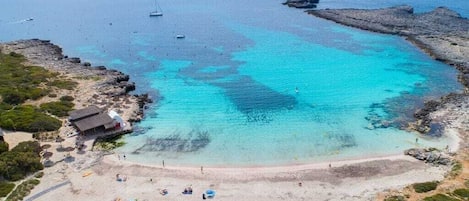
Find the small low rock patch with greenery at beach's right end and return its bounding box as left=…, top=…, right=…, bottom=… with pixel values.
left=404, top=148, right=453, bottom=165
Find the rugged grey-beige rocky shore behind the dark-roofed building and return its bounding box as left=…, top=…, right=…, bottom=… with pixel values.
left=0, top=39, right=151, bottom=122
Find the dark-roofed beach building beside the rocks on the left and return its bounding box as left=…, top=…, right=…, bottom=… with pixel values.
left=68, top=105, right=116, bottom=134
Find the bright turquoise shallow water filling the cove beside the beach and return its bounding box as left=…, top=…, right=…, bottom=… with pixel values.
left=120, top=20, right=455, bottom=166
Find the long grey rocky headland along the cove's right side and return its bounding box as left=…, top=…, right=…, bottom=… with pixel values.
left=307, top=6, right=469, bottom=134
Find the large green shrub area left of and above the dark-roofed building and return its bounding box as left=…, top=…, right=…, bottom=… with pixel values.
left=0, top=52, right=77, bottom=132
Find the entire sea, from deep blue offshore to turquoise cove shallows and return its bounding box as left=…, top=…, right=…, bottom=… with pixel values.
left=0, top=0, right=469, bottom=166
